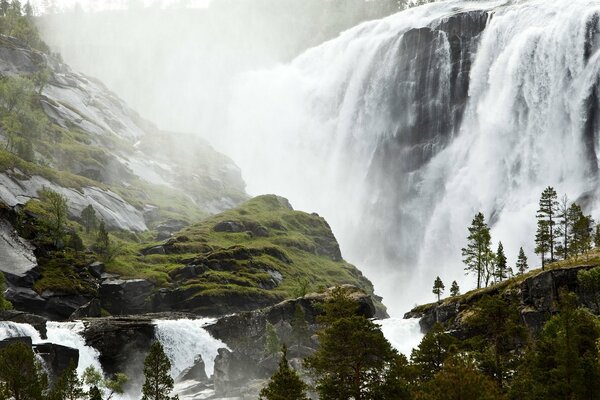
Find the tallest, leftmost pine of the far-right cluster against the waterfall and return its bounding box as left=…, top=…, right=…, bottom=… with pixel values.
left=536, top=186, right=559, bottom=262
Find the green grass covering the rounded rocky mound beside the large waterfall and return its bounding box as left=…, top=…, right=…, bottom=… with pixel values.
left=95, top=196, right=380, bottom=310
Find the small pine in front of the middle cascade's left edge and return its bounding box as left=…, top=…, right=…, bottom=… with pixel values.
left=142, top=342, right=173, bottom=400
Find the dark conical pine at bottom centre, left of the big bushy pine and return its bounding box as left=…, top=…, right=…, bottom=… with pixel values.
left=260, top=345, right=308, bottom=400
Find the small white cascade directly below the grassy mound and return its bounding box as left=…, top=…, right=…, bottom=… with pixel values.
left=153, top=318, right=227, bottom=378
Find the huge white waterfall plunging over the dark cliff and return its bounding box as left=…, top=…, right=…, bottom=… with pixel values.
left=222, top=0, right=600, bottom=314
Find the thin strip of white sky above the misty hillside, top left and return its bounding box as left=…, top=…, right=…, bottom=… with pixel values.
left=30, top=0, right=211, bottom=13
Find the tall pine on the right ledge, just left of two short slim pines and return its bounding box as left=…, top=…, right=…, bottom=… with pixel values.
left=462, top=213, right=492, bottom=289
